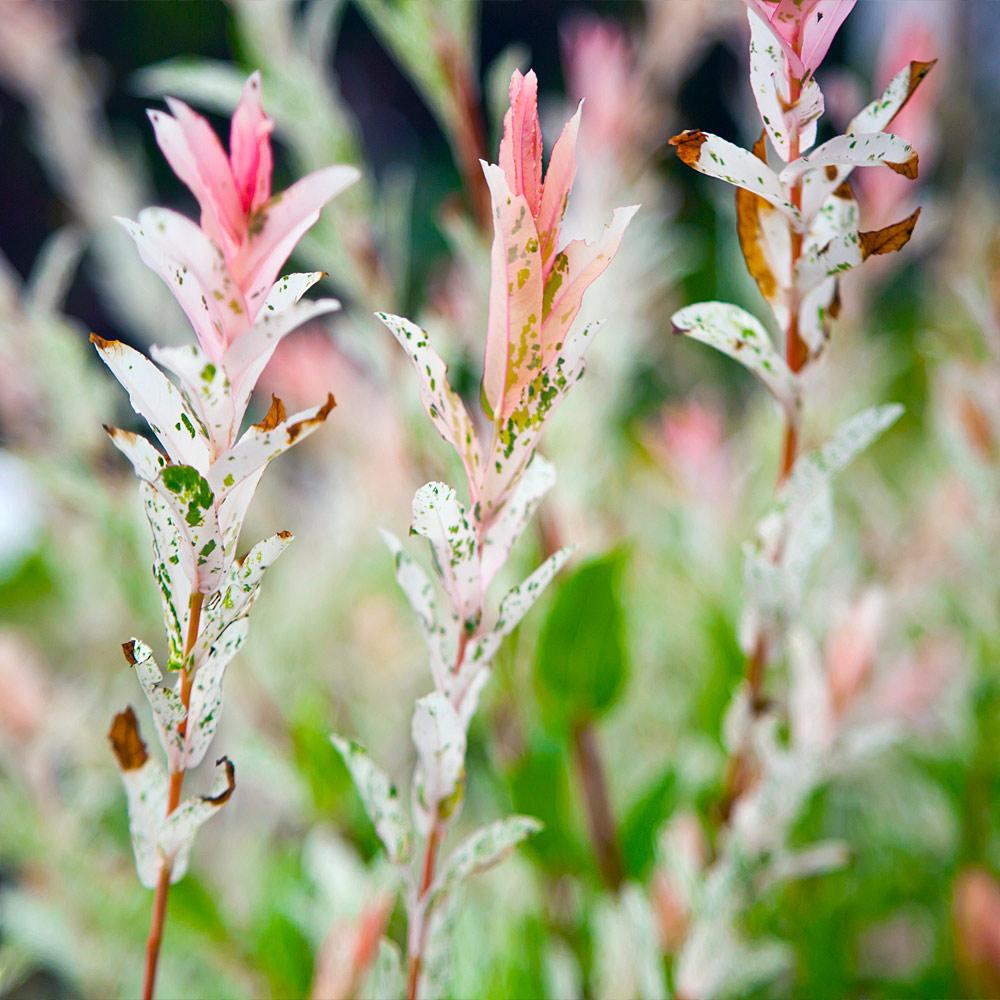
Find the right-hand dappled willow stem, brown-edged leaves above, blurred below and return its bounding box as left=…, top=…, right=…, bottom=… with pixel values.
left=666, top=0, right=933, bottom=996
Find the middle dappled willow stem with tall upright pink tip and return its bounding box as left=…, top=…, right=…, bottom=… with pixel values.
left=333, top=72, right=637, bottom=998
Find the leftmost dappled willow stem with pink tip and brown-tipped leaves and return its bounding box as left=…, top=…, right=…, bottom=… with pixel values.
left=91, top=74, right=357, bottom=997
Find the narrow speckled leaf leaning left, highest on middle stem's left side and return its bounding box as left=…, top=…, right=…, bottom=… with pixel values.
left=375, top=313, right=482, bottom=484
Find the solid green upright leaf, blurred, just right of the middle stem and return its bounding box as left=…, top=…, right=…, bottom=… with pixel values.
left=535, top=549, right=628, bottom=727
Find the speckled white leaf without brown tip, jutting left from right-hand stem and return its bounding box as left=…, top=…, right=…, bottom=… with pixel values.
left=672, top=302, right=799, bottom=414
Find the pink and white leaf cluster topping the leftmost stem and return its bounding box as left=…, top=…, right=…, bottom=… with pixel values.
left=135, top=73, right=358, bottom=362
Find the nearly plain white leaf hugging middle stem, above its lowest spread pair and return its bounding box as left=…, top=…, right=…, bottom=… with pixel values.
left=411, top=691, right=465, bottom=836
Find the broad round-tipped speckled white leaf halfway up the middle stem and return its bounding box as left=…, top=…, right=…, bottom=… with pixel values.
left=410, top=483, right=483, bottom=635
